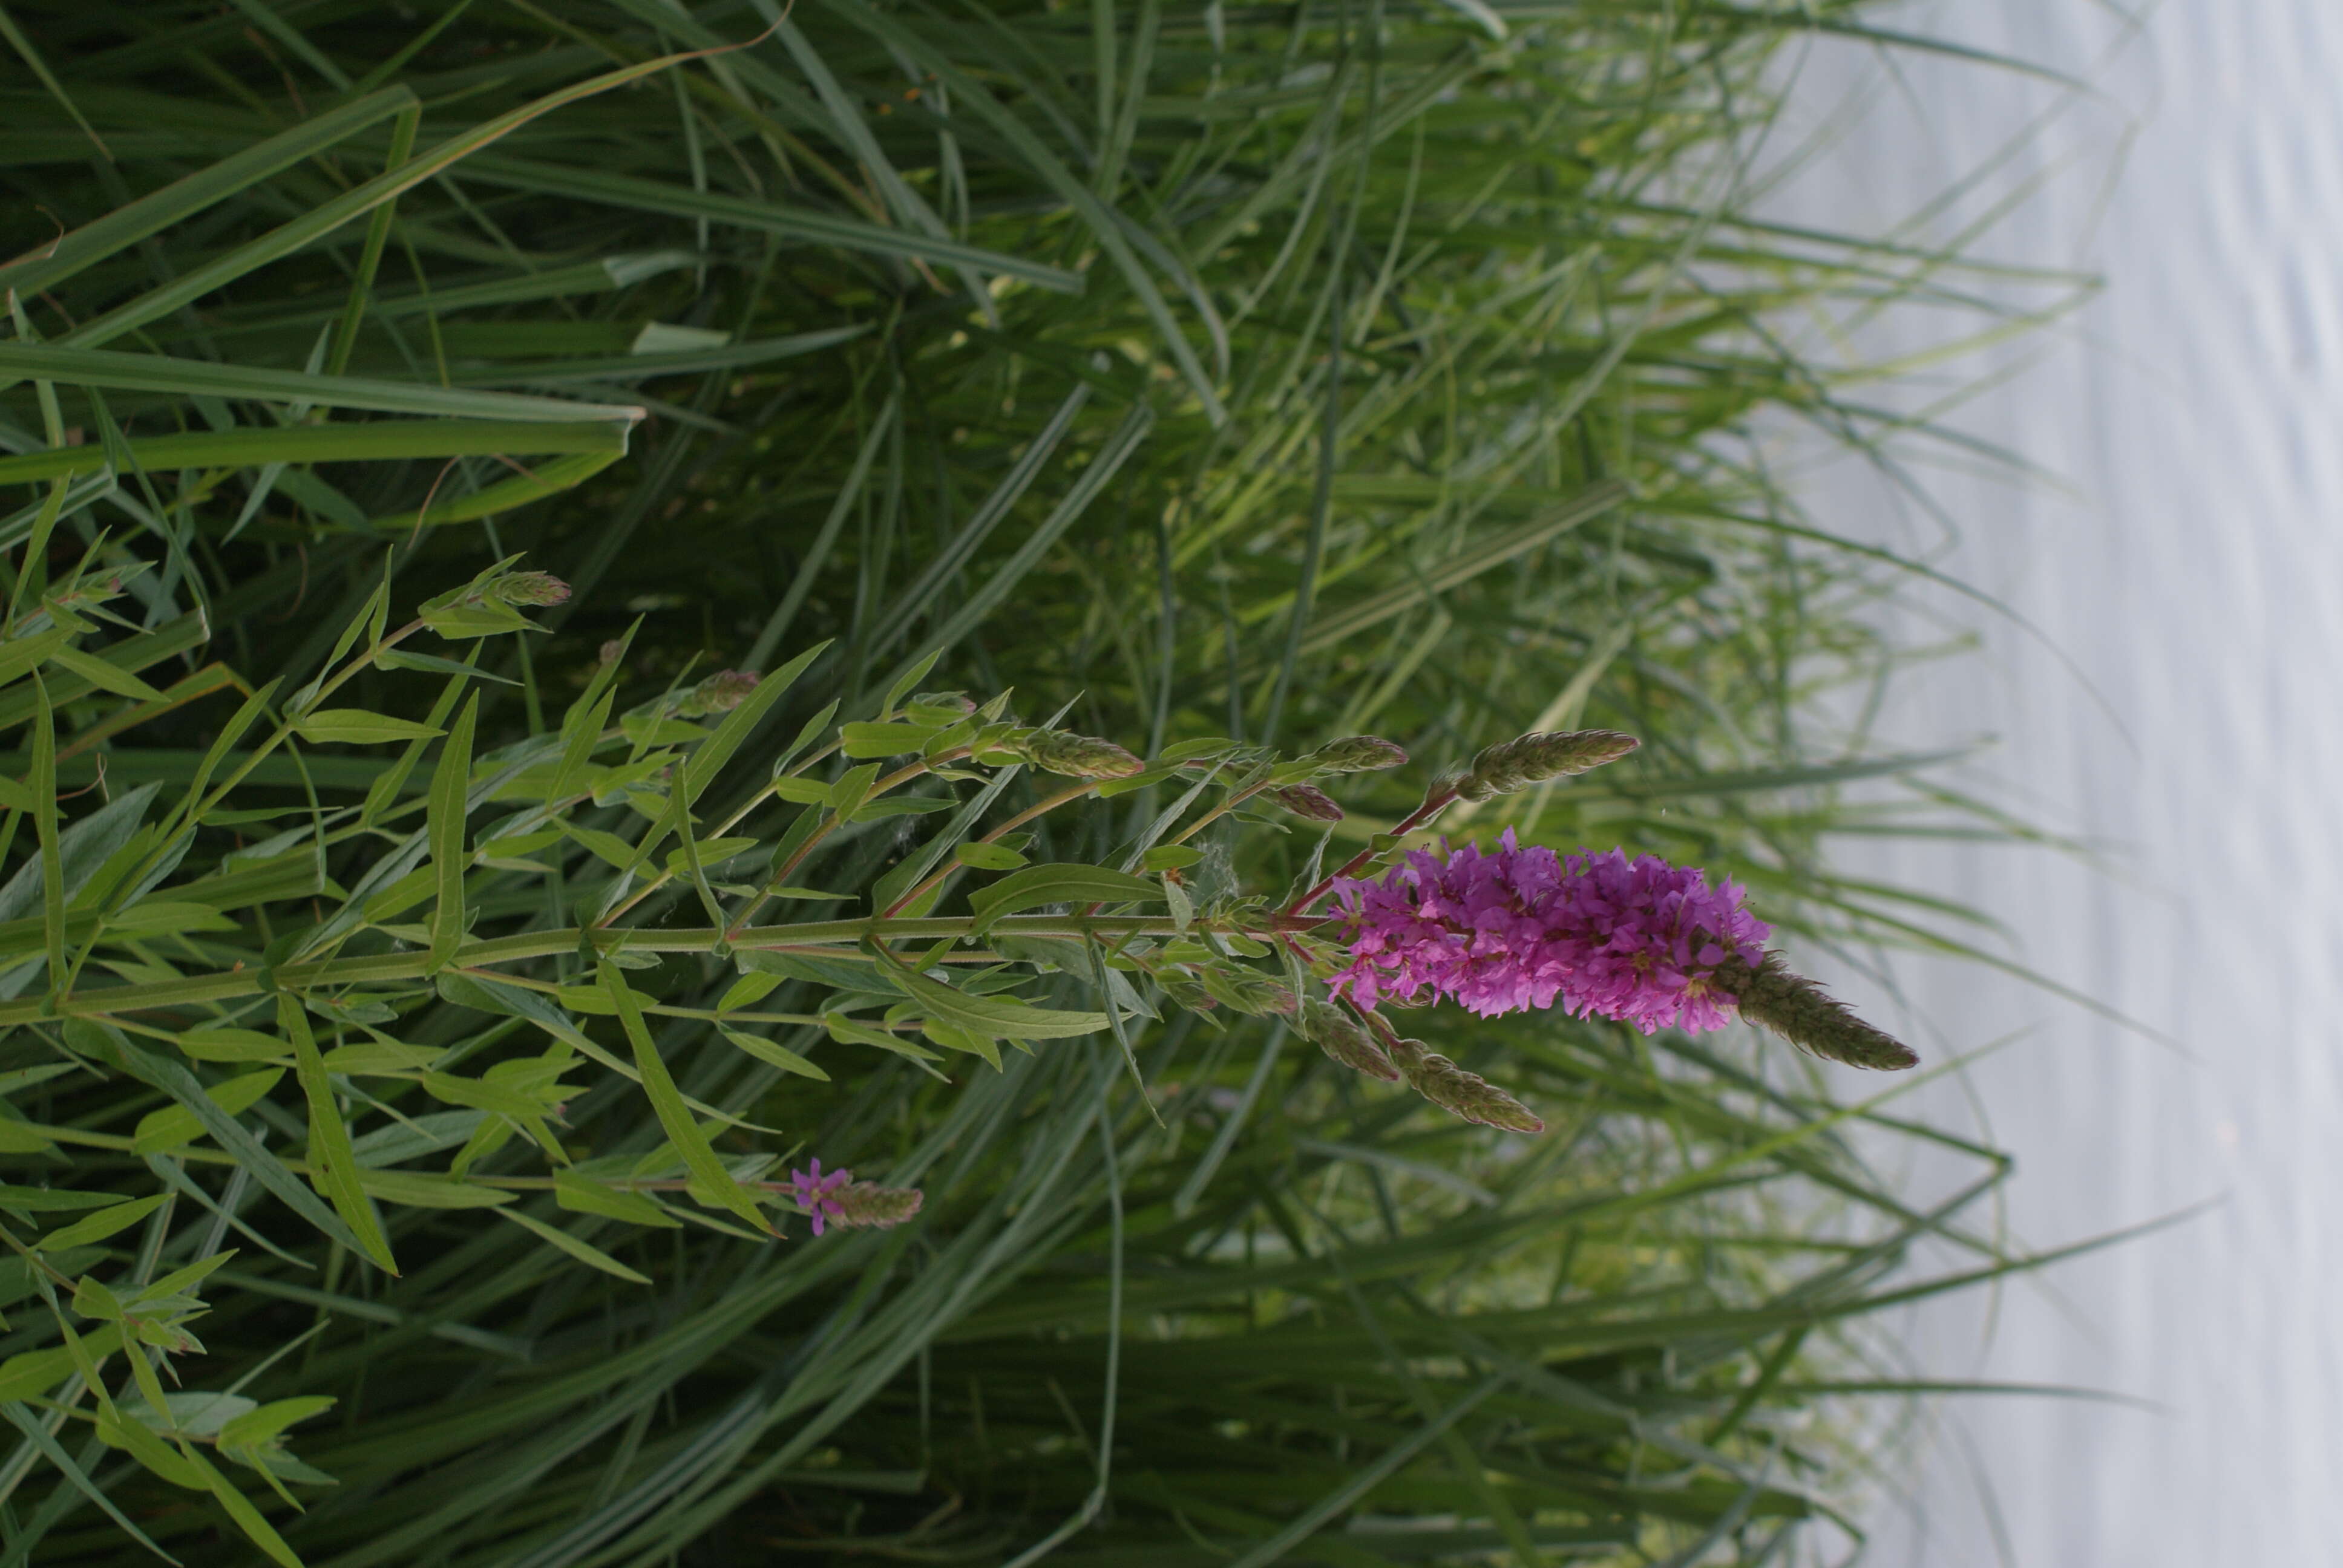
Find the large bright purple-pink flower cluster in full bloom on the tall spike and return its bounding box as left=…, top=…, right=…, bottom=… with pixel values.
left=1333, top=830, right=1769, bottom=1034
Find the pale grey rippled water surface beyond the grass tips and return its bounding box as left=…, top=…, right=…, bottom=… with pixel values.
left=1778, top=0, right=2343, bottom=1568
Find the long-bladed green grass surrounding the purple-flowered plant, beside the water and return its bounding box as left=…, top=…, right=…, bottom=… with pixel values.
left=0, top=0, right=2080, bottom=1568
